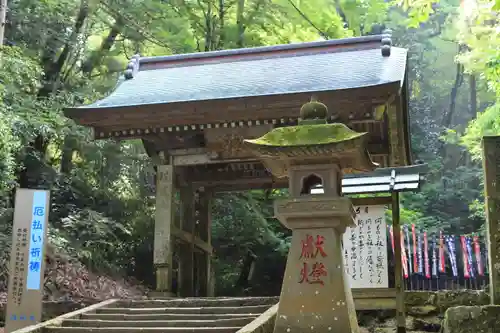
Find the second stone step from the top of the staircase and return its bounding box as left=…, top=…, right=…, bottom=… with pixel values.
left=96, top=305, right=270, bottom=314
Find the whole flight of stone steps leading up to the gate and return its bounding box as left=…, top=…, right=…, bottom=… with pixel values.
left=43, top=297, right=279, bottom=333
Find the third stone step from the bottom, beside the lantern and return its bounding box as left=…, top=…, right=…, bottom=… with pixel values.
left=80, top=313, right=260, bottom=321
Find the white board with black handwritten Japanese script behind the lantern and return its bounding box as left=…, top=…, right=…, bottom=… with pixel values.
left=343, top=206, right=389, bottom=288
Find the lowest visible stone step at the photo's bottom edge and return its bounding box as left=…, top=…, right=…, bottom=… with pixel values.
left=43, top=326, right=241, bottom=333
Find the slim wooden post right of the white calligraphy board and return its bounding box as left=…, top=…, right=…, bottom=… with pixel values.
left=392, top=192, right=406, bottom=333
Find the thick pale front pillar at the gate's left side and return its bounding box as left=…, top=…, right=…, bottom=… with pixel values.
left=153, top=165, right=175, bottom=293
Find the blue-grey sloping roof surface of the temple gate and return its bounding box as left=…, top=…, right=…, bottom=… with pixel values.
left=78, top=36, right=407, bottom=108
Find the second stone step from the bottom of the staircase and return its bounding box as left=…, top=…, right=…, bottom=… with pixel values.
left=62, top=318, right=253, bottom=329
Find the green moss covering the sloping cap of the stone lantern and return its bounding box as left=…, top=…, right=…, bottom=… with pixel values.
left=245, top=123, right=366, bottom=147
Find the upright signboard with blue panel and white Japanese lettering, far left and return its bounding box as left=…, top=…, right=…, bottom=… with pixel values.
left=5, top=189, right=50, bottom=333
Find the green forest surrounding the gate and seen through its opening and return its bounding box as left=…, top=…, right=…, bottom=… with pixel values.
left=0, top=0, right=500, bottom=302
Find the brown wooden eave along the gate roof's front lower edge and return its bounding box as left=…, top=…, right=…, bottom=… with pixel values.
left=65, top=82, right=400, bottom=131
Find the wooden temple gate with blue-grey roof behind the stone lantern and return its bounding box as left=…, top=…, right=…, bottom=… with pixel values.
left=65, top=32, right=422, bottom=332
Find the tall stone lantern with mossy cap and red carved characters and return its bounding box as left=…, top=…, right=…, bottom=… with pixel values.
left=245, top=100, right=377, bottom=333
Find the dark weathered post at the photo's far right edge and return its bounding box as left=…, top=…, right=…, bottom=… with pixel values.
left=483, top=136, right=500, bottom=304
